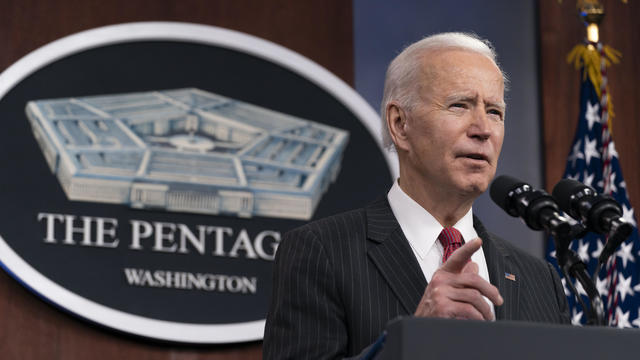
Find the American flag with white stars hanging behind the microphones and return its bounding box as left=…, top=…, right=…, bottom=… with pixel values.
left=547, top=44, right=640, bottom=328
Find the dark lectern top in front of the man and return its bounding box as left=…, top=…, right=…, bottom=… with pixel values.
left=376, top=317, right=640, bottom=360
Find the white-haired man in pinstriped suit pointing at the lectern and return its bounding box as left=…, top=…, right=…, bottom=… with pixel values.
left=264, top=33, right=569, bottom=359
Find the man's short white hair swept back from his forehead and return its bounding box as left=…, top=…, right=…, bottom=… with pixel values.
left=380, top=32, right=507, bottom=149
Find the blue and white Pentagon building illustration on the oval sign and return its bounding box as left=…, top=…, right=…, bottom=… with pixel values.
left=26, top=89, right=349, bottom=220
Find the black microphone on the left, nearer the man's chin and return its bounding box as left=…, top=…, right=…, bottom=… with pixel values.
left=489, top=175, right=571, bottom=238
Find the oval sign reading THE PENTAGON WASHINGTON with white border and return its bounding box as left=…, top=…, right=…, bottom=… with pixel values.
left=0, top=22, right=395, bottom=343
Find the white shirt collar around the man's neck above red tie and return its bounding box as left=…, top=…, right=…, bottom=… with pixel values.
left=387, top=180, right=478, bottom=259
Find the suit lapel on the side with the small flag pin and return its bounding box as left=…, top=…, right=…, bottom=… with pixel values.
left=473, top=216, right=521, bottom=320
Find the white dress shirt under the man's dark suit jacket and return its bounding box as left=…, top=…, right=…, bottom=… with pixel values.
left=387, top=180, right=495, bottom=315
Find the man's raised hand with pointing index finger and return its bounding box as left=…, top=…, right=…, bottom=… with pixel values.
left=414, top=238, right=504, bottom=320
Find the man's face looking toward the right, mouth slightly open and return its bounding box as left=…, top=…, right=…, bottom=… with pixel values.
left=400, top=50, right=505, bottom=196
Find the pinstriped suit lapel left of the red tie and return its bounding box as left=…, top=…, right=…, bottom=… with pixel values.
left=366, top=197, right=427, bottom=314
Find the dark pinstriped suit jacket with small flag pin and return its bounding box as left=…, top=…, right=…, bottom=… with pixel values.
left=263, top=197, right=569, bottom=359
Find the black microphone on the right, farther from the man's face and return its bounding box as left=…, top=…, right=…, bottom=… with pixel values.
left=553, top=179, right=633, bottom=263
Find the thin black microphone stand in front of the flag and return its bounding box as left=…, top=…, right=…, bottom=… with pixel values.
left=551, top=224, right=606, bottom=326
